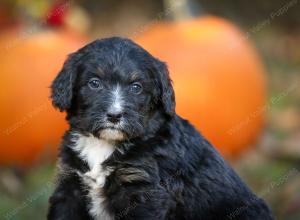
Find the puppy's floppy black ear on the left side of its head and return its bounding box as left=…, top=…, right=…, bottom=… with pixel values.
left=51, top=53, right=79, bottom=112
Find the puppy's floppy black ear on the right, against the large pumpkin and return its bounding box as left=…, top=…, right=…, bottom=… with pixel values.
left=155, top=60, right=175, bottom=117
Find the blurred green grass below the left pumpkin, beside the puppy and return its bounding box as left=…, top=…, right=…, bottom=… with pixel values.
left=0, top=164, right=54, bottom=220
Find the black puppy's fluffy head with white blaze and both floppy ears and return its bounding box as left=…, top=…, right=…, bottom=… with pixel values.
left=51, top=38, right=175, bottom=141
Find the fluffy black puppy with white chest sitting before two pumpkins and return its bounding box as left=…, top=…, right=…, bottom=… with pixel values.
left=48, top=38, right=272, bottom=220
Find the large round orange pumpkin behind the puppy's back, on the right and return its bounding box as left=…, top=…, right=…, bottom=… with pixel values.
left=136, top=16, right=266, bottom=158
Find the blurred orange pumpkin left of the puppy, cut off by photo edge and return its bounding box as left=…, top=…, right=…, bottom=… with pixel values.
left=0, top=31, right=85, bottom=165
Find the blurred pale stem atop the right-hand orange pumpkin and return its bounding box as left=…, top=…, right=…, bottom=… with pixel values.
left=164, top=0, right=203, bottom=20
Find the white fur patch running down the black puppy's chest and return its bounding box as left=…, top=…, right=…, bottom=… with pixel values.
left=73, top=133, right=115, bottom=220
